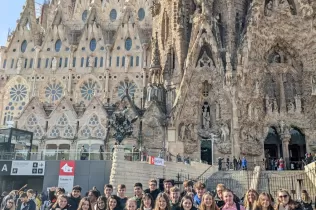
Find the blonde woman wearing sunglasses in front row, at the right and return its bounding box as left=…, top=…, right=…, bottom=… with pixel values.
left=274, top=189, right=303, bottom=210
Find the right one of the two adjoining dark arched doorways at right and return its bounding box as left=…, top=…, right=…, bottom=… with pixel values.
left=289, top=128, right=306, bottom=162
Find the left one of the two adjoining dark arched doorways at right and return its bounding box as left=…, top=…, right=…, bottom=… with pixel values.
left=264, top=127, right=283, bottom=169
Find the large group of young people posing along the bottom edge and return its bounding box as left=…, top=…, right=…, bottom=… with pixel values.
left=0, top=179, right=316, bottom=210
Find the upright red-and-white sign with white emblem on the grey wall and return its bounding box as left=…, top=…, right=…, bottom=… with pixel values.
left=58, top=160, right=76, bottom=192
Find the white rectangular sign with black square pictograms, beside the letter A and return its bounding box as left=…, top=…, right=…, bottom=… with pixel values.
left=11, top=161, right=45, bottom=176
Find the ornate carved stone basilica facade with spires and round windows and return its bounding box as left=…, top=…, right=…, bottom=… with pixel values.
left=0, top=0, right=316, bottom=162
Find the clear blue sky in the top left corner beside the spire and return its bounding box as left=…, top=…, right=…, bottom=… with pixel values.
left=0, top=0, right=25, bottom=46
